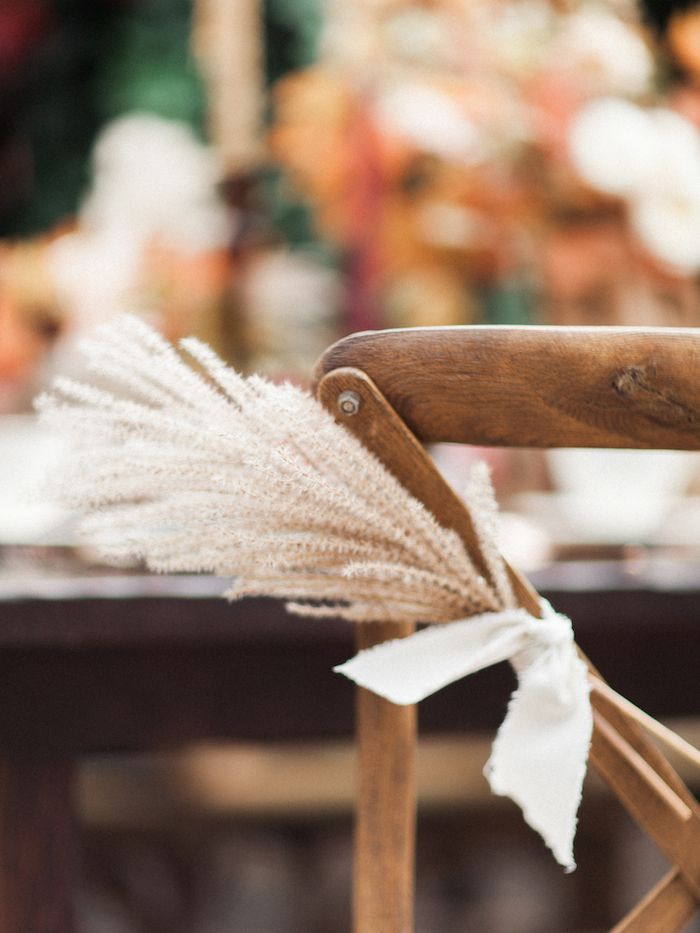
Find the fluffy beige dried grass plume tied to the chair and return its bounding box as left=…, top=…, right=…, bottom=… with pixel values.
left=37, top=317, right=513, bottom=622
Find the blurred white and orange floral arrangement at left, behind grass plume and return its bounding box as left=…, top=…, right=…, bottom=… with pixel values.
left=0, top=113, right=235, bottom=412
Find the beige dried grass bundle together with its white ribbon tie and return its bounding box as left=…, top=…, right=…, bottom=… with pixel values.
left=38, top=317, right=592, bottom=869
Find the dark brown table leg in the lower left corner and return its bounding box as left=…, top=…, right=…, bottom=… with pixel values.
left=0, top=758, right=77, bottom=933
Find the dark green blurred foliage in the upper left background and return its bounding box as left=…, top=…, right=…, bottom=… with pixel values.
left=0, top=0, right=322, bottom=244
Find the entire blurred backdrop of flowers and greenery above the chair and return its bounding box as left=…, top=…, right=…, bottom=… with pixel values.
left=0, top=0, right=700, bottom=540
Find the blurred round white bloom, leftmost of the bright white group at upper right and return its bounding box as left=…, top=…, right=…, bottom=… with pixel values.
left=569, top=97, right=659, bottom=196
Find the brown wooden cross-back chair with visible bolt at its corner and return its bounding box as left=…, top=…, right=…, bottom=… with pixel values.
left=316, top=327, right=700, bottom=933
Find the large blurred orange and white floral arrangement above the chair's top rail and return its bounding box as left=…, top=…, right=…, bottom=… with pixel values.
left=270, top=0, right=700, bottom=329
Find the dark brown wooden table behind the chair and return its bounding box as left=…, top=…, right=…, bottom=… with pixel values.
left=0, top=559, right=700, bottom=933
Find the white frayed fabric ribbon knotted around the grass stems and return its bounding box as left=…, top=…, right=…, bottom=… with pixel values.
left=335, top=603, right=593, bottom=871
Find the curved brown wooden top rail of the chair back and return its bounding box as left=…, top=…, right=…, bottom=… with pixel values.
left=315, top=326, right=700, bottom=450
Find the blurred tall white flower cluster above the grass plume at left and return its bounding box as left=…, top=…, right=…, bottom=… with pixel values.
left=42, top=114, right=232, bottom=342
